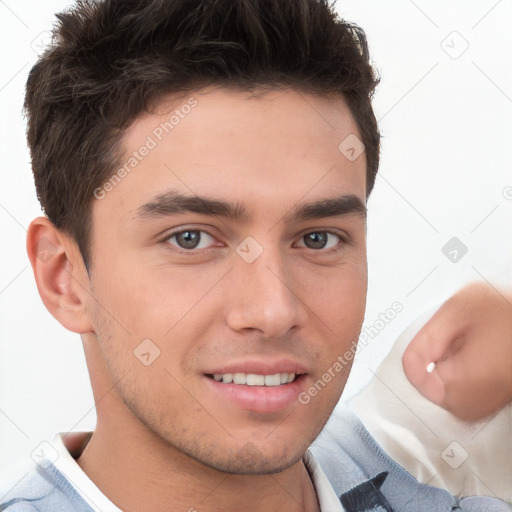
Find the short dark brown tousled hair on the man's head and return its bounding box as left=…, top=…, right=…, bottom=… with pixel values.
left=24, top=0, right=380, bottom=269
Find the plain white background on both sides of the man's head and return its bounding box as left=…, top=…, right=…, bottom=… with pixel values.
left=0, top=0, right=512, bottom=484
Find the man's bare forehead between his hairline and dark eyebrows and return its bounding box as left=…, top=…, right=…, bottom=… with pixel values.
left=97, top=88, right=366, bottom=222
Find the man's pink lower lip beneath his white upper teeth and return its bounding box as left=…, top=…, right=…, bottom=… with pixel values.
left=205, top=374, right=306, bottom=413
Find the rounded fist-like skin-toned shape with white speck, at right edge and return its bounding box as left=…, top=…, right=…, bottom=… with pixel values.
left=403, top=283, right=512, bottom=421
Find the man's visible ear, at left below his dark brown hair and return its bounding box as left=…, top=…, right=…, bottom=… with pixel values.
left=27, top=217, right=93, bottom=334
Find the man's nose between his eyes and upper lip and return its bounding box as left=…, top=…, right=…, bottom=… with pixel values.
left=226, top=245, right=307, bottom=339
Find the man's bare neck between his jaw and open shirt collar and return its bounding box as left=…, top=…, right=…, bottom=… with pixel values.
left=77, top=336, right=319, bottom=512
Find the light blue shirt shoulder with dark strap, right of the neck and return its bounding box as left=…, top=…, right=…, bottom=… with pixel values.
left=310, top=404, right=512, bottom=512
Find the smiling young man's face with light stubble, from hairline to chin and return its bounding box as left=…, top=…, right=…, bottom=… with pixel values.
left=86, top=89, right=367, bottom=473
